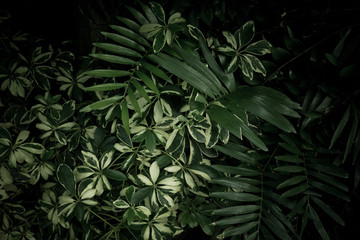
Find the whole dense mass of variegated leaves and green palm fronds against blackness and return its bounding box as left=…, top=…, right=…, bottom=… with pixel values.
left=0, top=2, right=359, bottom=240
